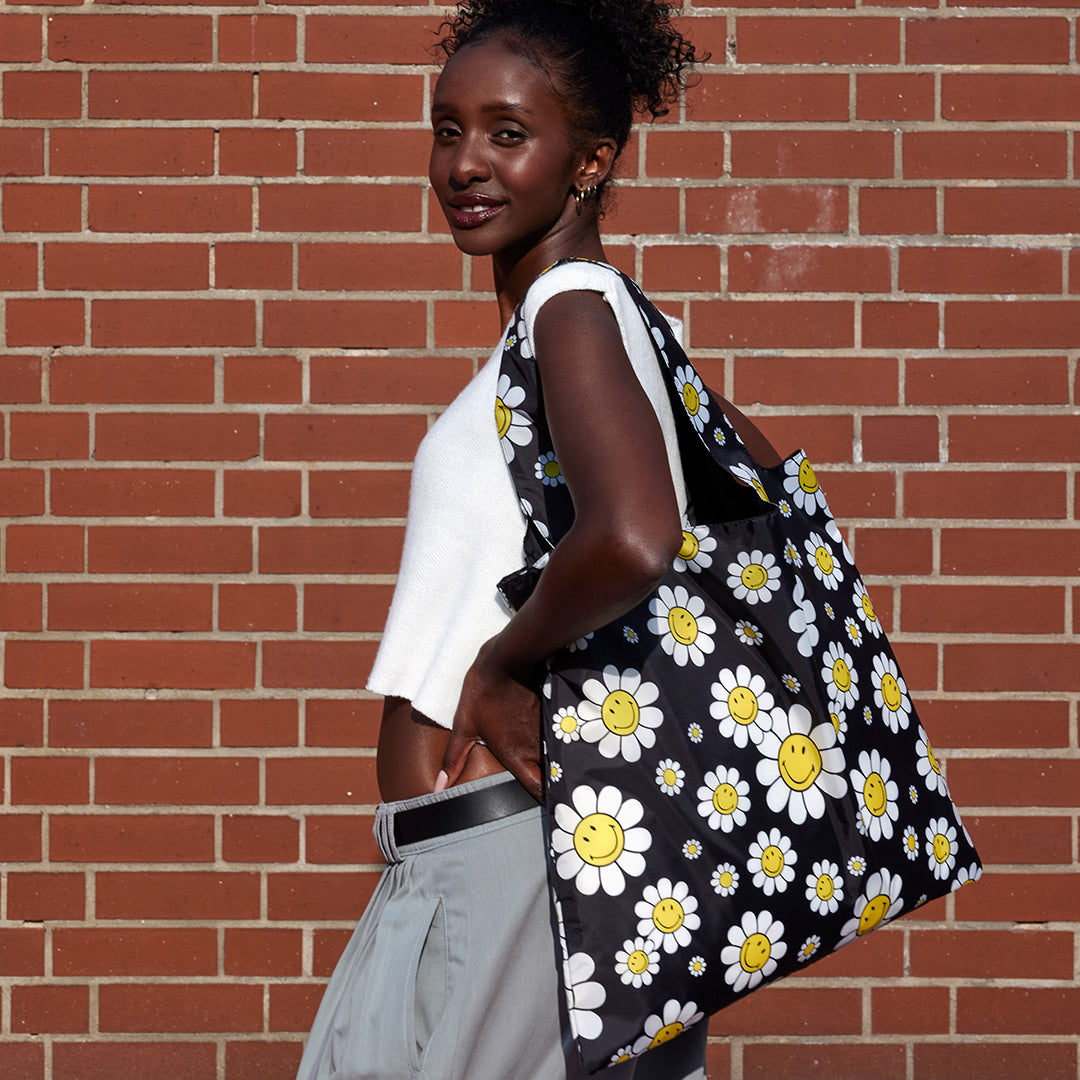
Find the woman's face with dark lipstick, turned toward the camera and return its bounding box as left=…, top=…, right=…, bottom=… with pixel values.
left=429, top=40, right=581, bottom=260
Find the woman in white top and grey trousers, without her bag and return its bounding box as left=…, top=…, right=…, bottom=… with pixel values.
left=299, top=0, right=775, bottom=1080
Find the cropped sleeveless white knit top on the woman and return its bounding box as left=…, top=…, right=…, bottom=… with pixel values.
left=367, top=262, right=686, bottom=728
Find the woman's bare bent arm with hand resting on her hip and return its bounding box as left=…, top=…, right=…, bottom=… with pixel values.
left=437, top=292, right=683, bottom=799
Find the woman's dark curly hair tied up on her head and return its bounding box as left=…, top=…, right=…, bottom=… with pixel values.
left=438, top=0, right=708, bottom=192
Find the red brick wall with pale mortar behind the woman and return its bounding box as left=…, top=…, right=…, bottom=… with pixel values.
left=0, top=0, right=1080, bottom=1080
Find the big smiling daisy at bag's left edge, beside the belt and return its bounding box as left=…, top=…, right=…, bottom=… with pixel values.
left=551, top=784, right=652, bottom=896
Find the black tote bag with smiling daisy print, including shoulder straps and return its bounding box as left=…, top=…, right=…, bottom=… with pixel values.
left=496, top=264, right=982, bottom=1071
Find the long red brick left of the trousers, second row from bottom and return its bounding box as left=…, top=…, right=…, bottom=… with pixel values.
left=97, top=983, right=262, bottom=1034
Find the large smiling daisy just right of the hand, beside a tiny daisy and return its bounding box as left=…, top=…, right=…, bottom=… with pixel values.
left=578, top=664, right=664, bottom=761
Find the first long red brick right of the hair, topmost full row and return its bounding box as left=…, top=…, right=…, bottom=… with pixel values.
left=735, top=15, right=910, bottom=64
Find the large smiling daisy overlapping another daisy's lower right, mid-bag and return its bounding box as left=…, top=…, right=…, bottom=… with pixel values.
left=757, top=705, right=848, bottom=825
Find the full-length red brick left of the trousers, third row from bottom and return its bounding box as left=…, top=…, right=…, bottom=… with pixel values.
left=53, top=927, right=217, bottom=977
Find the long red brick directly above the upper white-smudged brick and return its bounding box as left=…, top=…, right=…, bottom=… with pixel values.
left=731, top=129, right=894, bottom=178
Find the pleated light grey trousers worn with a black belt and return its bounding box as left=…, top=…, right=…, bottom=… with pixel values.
left=297, top=773, right=707, bottom=1080
